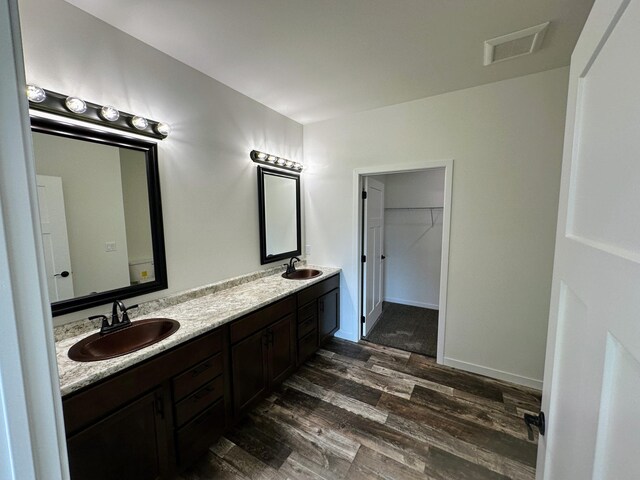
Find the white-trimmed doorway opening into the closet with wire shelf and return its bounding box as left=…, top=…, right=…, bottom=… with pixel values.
left=360, top=160, right=451, bottom=359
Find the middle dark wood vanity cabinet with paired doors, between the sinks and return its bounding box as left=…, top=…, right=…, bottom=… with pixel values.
left=231, top=296, right=296, bottom=418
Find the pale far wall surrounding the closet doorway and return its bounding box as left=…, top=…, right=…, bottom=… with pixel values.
left=304, top=68, right=568, bottom=386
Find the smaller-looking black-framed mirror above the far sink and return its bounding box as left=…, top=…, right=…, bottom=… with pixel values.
left=258, top=167, right=301, bottom=265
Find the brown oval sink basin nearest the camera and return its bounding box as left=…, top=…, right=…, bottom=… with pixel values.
left=69, top=318, right=180, bottom=362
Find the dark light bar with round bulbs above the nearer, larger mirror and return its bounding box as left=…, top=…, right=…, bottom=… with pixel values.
left=29, top=85, right=169, bottom=139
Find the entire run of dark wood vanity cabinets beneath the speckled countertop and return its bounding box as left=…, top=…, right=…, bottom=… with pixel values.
left=62, top=275, right=340, bottom=480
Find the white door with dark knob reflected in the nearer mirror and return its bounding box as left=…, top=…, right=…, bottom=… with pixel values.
left=37, top=175, right=74, bottom=302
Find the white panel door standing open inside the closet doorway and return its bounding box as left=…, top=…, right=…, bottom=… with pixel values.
left=362, top=177, right=384, bottom=336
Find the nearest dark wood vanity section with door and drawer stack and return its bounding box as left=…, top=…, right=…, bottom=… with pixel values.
left=62, top=326, right=229, bottom=480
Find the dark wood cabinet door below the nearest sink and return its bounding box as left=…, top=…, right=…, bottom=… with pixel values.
left=67, top=388, right=167, bottom=480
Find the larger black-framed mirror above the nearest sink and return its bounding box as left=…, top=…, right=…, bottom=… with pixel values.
left=31, top=117, right=168, bottom=316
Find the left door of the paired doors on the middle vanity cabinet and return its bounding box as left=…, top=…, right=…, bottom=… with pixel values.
left=231, top=329, right=269, bottom=416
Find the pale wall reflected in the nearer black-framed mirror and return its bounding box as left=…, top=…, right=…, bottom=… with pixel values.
left=33, top=133, right=129, bottom=297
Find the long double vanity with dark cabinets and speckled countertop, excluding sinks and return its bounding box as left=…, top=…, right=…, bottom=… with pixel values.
left=56, top=267, right=340, bottom=480
